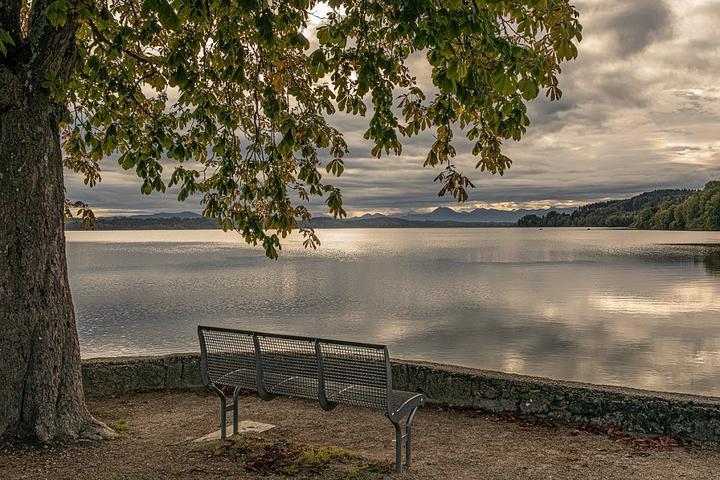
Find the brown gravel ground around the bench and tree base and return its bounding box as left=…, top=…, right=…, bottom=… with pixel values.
left=0, top=392, right=720, bottom=480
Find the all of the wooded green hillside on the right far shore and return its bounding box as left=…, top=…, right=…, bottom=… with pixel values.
left=518, top=181, right=720, bottom=230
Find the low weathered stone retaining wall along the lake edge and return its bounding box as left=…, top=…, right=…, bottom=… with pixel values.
left=83, top=354, right=720, bottom=443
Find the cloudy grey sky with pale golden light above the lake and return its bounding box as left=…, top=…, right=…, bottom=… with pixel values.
left=65, top=0, right=720, bottom=216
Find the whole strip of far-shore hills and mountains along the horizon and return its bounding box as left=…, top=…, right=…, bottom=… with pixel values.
left=66, top=187, right=720, bottom=230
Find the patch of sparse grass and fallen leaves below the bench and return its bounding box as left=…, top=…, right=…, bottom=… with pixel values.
left=208, top=435, right=392, bottom=480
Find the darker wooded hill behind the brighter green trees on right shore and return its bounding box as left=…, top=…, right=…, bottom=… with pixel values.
left=518, top=189, right=695, bottom=227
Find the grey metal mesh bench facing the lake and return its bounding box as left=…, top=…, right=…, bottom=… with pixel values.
left=198, top=326, right=425, bottom=472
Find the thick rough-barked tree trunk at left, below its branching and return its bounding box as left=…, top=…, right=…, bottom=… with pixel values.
left=0, top=79, right=112, bottom=442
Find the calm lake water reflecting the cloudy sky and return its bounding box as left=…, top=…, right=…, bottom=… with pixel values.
left=67, top=228, right=720, bottom=395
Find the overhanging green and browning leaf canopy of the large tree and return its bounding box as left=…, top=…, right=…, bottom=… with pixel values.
left=0, top=0, right=581, bottom=258
